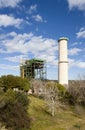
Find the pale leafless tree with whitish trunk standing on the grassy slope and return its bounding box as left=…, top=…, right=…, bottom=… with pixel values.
left=45, top=82, right=60, bottom=116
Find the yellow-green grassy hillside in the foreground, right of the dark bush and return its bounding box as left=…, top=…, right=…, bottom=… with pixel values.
left=29, top=96, right=85, bottom=130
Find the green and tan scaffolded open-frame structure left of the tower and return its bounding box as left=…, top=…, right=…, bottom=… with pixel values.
left=20, top=59, right=46, bottom=80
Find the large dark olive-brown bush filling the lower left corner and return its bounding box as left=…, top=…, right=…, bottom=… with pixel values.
left=0, top=90, right=30, bottom=130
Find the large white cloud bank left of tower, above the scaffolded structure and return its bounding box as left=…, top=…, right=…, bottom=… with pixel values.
left=0, top=32, right=58, bottom=64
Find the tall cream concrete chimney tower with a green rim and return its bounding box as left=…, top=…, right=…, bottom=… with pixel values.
left=58, top=37, right=68, bottom=86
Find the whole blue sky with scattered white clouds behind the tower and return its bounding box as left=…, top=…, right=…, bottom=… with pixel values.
left=0, top=0, right=85, bottom=80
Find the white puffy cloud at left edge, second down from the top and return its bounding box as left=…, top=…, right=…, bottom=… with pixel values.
left=0, top=14, right=23, bottom=27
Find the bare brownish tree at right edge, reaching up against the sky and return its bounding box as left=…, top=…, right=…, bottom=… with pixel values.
left=68, top=76, right=85, bottom=106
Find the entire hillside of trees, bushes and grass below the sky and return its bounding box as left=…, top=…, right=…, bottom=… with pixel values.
left=0, top=75, right=85, bottom=130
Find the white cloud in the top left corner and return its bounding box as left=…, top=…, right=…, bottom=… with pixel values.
left=0, top=0, right=22, bottom=8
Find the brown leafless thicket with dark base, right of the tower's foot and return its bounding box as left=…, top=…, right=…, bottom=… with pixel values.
left=65, top=80, right=85, bottom=107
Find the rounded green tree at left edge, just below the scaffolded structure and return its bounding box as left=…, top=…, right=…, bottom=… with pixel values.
left=0, top=75, right=30, bottom=92
